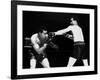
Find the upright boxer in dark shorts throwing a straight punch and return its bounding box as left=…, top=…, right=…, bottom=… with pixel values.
left=54, top=17, right=88, bottom=67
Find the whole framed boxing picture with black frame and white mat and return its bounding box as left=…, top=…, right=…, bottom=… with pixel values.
left=11, top=1, right=97, bottom=78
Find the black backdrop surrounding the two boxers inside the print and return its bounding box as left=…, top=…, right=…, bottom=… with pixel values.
left=22, top=11, right=90, bottom=68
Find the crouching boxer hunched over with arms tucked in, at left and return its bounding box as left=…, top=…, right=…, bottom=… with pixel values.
left=30, top=27, right=50, bottom=68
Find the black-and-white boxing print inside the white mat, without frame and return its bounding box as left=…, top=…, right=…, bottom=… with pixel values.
left=23, top=11, right=89, bottom=68
